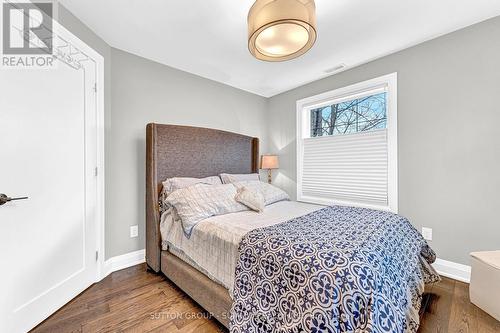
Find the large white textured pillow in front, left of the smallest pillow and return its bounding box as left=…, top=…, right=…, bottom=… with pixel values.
left=165, top=184, right=248, bottom=238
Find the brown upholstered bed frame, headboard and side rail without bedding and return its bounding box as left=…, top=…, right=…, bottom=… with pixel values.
left=146, top=124, right=259, bottom=327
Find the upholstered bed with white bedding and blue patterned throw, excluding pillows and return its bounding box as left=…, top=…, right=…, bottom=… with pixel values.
left=146, top=124, right=439, bottom=332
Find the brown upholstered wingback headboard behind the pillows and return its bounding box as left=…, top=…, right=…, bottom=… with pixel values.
left=146, top=124, right=259, bottom=272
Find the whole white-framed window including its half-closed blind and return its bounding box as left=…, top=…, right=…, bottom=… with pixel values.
left=297, top=73, right=398, bottom=213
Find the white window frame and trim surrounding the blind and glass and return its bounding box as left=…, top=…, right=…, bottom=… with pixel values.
left=296, top=72, right=398, bottom=213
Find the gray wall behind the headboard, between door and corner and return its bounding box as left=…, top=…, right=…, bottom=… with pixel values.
left=59, top=6, right=267, bottom=259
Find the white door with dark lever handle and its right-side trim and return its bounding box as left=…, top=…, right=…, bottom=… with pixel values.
left=0, top=24, right=100, bottom=333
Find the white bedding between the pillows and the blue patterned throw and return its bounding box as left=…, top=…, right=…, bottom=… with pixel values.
left=161, top=201, right=322, bottom=295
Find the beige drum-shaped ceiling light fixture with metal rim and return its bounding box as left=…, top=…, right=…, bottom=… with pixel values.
left=248, top=0, right=316, bottom=61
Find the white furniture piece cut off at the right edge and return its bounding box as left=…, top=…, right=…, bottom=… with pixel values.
left=469, top=251, right=500, bottom=320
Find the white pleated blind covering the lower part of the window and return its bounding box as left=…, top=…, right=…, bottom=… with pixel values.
left=302, top=129, right=388, bottom=206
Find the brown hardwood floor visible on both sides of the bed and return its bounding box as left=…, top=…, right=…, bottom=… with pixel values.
left=32, top=264, right=500, bottom=333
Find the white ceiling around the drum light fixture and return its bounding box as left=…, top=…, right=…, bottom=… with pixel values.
left=60, top=0, right=500, bottom=97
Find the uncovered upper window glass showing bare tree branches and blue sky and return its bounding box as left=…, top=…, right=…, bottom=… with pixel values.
left=311, top=92, right=387, bottom=137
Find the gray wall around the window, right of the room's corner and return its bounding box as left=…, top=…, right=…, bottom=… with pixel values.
left=269, top=18, right=500, bottom=264
